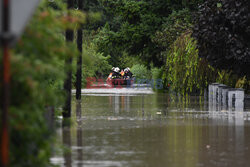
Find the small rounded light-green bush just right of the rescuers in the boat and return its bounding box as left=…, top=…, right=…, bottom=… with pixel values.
left=131, top=64, right=151, bottom=79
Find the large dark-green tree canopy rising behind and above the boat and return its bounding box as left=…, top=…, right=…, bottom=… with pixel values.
left=95, top=0, right=202, bottom=67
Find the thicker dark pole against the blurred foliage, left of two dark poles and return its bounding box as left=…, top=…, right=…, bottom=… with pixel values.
left=63, top=0, right=74, bottom=118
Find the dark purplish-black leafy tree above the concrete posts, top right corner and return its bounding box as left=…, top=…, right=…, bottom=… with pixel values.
left=193, top=0, right=250, bottom=77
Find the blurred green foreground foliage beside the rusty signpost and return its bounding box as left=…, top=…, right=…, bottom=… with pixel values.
left=0, top=0, right=84, bottom=167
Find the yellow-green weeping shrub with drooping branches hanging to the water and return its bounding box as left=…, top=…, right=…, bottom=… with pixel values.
left=166, top=32, right=215, bottom=94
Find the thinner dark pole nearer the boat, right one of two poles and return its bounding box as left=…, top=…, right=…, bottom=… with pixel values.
left=76, top=0, right=83, bottom=100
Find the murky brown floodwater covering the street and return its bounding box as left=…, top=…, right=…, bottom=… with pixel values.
left=51, top=89, right=250, bottom=167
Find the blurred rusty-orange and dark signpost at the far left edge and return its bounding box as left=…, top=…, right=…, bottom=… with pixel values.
left=1, top=0, right=10, bottom=167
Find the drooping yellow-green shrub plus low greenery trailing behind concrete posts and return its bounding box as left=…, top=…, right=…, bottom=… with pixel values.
left=162, top=31, right=249, bottom=94
